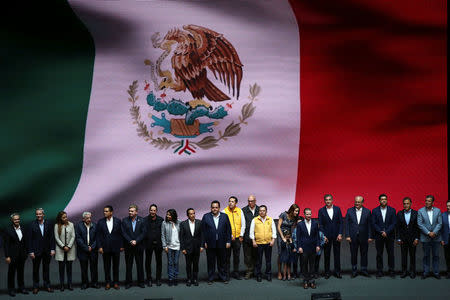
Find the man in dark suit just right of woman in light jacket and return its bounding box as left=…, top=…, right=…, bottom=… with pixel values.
left=180, top=208, right=203, bottom=286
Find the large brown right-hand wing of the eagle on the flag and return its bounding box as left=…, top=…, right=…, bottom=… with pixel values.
left=183, top=25, right=242, bottom=99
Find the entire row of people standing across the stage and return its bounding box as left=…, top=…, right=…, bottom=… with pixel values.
left=4, top=194, right=450, bottom=295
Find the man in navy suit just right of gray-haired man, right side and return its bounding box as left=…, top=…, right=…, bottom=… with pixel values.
left=372, top=194, right=397, bottom=278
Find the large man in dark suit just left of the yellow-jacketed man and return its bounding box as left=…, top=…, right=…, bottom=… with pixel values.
left=202, top=200, right=231, bottom=284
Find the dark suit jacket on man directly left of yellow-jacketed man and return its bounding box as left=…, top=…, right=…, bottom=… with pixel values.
left=202, top=212, right=231, bottom=248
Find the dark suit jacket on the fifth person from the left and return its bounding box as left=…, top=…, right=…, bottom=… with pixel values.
left=97, top=217, right=123, bottom=253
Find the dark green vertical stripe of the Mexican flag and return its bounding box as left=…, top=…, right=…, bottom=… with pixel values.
left=0, top=0, right=95, bottom=225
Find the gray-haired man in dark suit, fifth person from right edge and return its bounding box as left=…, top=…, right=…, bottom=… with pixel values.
left=345, top=196, right=372, bottom=278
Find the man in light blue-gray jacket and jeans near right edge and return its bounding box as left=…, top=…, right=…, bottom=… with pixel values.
left=417, top=195, right=442, bottom=279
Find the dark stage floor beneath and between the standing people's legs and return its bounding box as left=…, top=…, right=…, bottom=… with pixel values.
left=0, top=242, right=450, bottom=300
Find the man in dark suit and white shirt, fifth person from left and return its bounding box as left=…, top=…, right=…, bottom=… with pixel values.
left=97, top=205, right=123, bottom=290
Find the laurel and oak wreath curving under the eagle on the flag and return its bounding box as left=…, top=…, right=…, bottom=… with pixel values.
left=127, top=80, right=261, bottom=150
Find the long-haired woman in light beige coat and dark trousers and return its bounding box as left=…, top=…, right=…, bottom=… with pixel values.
left=55, top=211, right=77, bottom=291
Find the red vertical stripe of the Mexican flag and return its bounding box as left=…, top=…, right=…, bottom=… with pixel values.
left=290, top=0, right=448, bottom=214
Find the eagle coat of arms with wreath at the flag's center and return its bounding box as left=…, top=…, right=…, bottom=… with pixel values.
left=128, top=25, right=261, bottom=155
